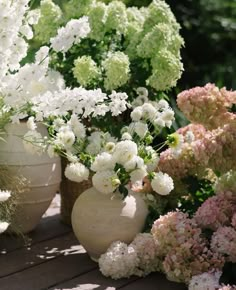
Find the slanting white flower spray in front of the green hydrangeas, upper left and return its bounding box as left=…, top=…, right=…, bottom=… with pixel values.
left=50, top=16, right=90, bottom=52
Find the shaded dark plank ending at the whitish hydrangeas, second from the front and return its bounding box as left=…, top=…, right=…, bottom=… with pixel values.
left=0, top=251, right=97, bottom=290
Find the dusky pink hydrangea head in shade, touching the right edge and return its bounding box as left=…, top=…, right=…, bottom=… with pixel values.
left=194, top=192, right=236, bottom=230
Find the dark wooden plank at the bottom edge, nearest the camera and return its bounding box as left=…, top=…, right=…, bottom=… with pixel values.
left=49, top=269, right=138, bottom=290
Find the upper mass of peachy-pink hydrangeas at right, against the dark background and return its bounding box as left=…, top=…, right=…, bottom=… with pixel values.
left=158, top=84, right=236, bottom=197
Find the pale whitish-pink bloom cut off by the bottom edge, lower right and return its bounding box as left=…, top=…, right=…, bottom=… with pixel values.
left=188, top=271, right=222, bottom=290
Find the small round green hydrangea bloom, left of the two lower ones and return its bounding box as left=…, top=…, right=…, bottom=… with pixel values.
left=72, top=55, right=100, bottom=87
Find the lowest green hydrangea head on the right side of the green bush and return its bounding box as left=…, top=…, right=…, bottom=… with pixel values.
left=147, top=50, right=183, bottom=91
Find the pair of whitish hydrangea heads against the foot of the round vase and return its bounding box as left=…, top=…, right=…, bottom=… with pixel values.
left=99, top=233, right=160, bottom=279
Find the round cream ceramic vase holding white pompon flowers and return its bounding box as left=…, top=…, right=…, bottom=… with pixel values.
left=71, top=187, right=148, bottom=261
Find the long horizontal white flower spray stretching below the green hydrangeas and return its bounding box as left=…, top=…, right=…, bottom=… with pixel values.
left=31, top=87, right=128, bottom=121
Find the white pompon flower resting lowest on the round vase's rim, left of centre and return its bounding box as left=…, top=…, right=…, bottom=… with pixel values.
left=92, top=170, right=120, bottom=194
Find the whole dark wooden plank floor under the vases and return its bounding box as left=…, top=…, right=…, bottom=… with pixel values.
left=0, top=197, right=186, bottom=290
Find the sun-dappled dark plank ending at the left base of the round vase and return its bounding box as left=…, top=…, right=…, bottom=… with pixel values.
left=0, top=233, right=80, bottom=277
